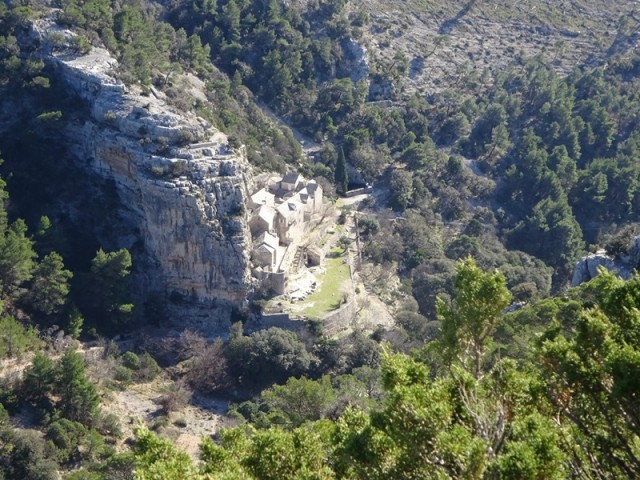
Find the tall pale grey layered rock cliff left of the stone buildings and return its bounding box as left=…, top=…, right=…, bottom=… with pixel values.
left=37, top=24, right=251, bottom=330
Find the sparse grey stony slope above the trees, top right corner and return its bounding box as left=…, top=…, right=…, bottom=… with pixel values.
left=342, top=0, right=640, bottom=94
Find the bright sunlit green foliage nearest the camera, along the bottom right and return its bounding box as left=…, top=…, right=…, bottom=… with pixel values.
left=130, top=259, right=640, bottom=479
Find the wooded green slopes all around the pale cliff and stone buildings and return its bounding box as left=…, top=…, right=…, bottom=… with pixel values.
left=0, top=0, right=640, bottom=479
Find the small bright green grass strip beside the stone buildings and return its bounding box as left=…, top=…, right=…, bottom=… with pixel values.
left=300, top=247, right=349, bottom=319
